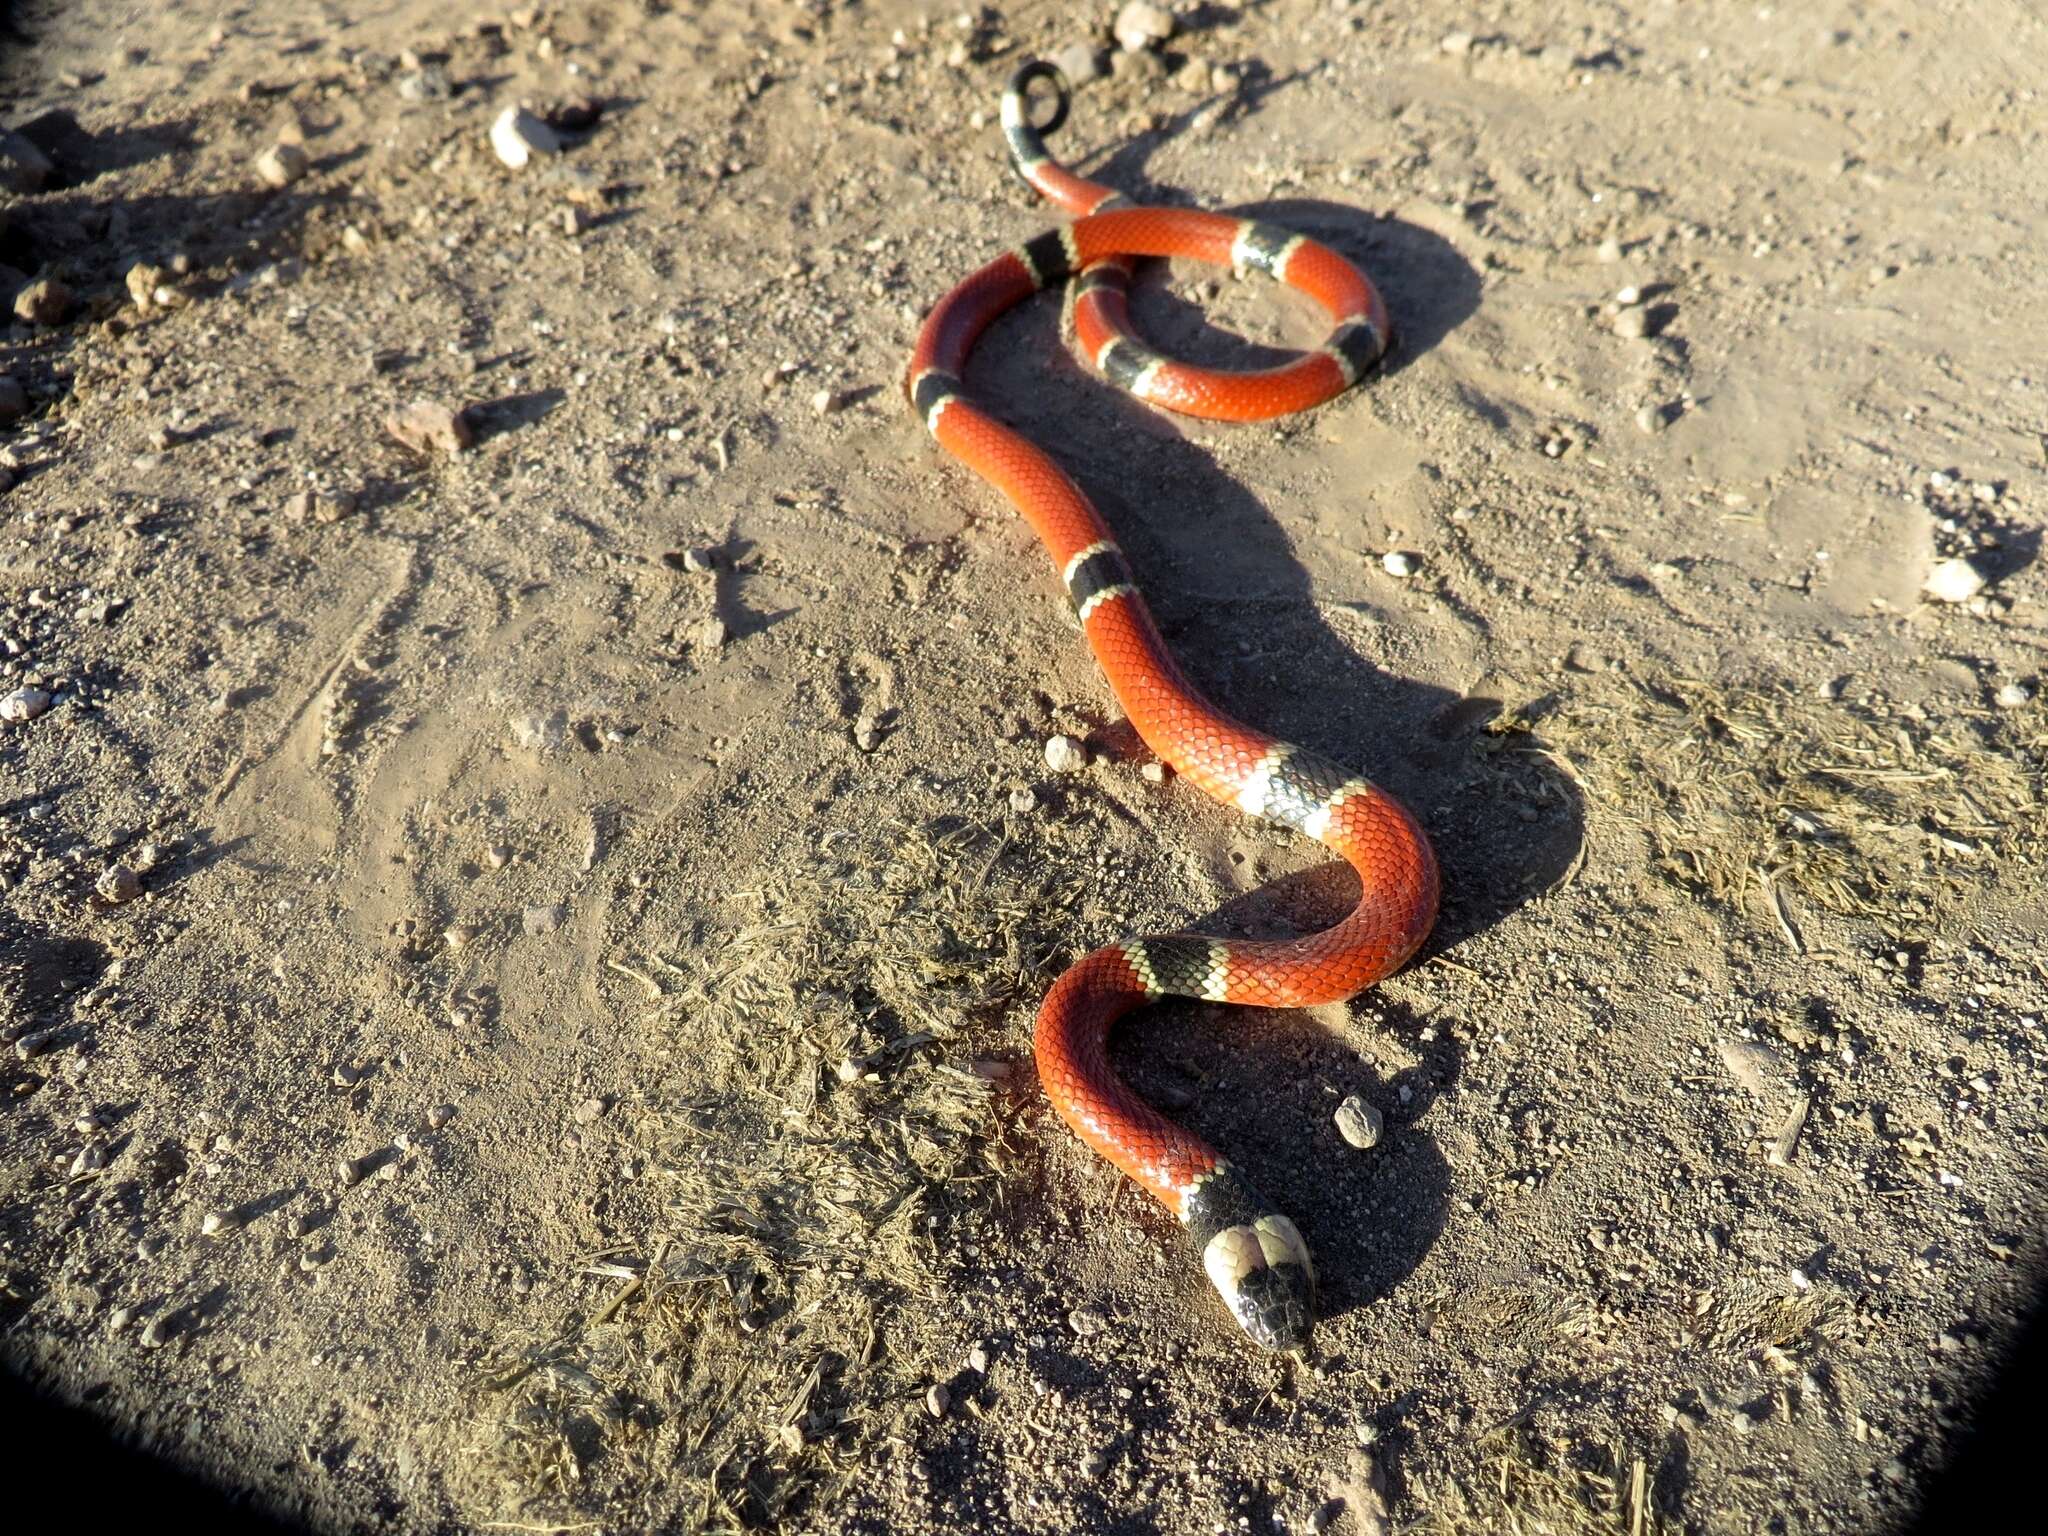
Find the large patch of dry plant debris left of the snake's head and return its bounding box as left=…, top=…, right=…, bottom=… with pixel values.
left=456, top=819, right=1077, bottom=1530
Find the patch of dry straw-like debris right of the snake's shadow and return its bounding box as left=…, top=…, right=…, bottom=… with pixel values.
left=1489, top=674, right=2048, bottom=948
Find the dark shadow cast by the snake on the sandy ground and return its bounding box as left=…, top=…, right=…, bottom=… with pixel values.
left=967, top=83, right=1585, bottom=1354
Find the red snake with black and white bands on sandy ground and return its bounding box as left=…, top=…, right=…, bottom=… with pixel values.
left=903, top=59, right=1440, bottom=1358
